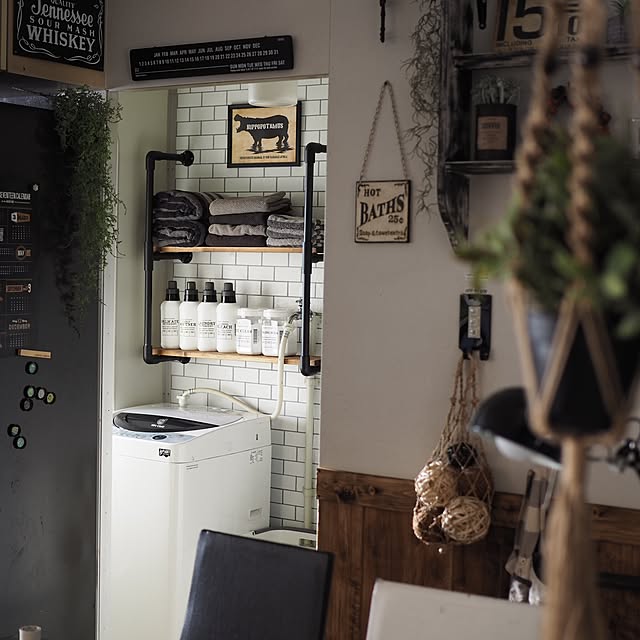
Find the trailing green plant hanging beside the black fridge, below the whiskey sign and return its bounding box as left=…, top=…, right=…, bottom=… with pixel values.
left=52, top=87, right=122, bottom=329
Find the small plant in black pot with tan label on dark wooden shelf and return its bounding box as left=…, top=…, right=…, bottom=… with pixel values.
left=472, top=76, right=520, bottom=160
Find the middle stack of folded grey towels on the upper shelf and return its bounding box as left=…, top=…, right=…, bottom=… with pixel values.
left=205, top=191, right=291, bottom=247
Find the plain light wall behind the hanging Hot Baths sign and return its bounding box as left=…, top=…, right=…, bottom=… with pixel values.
left=320, top=0, right=640, bottom=508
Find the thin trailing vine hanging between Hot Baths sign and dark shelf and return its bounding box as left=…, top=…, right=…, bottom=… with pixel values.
left=405, top=0, right=440, bottom=212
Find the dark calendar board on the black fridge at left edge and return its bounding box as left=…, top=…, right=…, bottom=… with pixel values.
left=0, top=187, right=35, bottom=357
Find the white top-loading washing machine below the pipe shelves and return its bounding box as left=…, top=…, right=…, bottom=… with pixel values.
left=106, top=404, right=271, bottom=640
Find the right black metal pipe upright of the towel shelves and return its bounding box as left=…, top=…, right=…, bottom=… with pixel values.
left=300, top=142, right=327, bottom=376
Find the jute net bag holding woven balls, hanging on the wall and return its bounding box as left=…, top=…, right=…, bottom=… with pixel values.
left=413, top=355, right=493, bottom=545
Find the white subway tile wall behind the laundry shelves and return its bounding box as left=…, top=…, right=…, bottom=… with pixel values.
left=167, top=79, right=329, bottom=527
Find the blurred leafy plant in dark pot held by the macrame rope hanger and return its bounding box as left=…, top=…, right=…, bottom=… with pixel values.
left=459, top=129, right=640, bottom=434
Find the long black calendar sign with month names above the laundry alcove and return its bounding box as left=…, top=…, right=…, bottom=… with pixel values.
left=129, top=36, right=293, bottom=80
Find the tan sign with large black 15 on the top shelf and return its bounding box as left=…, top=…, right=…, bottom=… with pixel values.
left=494, top=0, right=580, bottom=53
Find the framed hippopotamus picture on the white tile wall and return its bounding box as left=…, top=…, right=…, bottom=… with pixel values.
left=227, top=102, right=301, bottom=167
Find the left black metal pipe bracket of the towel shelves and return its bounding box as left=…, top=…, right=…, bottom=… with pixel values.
left=142, top=151, right=194, bottom=364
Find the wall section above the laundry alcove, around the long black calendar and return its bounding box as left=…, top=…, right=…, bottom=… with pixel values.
left=106, top=0, right=329, bottom=89
